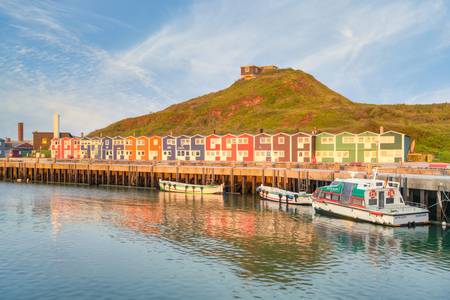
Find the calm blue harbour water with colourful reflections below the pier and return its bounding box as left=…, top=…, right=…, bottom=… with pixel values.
left=0, top=183, right=450, bottom=299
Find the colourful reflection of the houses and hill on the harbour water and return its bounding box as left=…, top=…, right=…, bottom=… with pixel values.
left=41, top=185, right=450, bottom=283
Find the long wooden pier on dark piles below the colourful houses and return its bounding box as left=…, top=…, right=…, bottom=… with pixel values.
left=0, top=159, right=450, bottom=221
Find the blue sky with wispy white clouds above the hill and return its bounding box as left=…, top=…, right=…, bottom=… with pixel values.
left=0, top=0, right=450, bottom=138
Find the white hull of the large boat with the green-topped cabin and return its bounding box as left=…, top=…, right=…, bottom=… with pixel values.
left=312, top=201, right=429, bottom=227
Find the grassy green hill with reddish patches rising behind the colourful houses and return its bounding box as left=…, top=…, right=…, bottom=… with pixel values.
left=90, top=69, right=450, bottom=161
